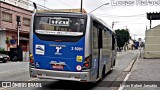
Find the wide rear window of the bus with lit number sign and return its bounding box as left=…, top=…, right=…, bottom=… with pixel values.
left=35, top=17, right=86, bottom=36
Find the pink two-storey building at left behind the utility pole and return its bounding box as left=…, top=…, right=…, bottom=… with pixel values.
left=0, top=0, right=32, bottom=52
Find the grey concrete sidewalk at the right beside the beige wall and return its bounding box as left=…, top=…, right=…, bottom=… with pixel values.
left=123, top=53, right=160, bottom=90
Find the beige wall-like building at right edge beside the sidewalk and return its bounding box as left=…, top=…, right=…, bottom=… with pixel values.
left=144, top=25, right=160, bottom=58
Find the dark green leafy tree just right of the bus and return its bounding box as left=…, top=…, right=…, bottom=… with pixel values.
left=115, top=29, right=130, bottom=50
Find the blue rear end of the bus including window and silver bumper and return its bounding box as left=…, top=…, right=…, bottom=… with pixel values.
left=30, top=14, right=90, bottom=81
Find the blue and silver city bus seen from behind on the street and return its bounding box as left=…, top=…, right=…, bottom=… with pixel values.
left=29, top=12, right=117, bottom=82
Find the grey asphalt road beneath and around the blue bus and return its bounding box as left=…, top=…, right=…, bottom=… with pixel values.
left=0, top=50, right=139, bottom=90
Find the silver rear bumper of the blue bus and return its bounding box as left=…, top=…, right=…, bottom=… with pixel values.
left=30, top=68, right=91, bottom=82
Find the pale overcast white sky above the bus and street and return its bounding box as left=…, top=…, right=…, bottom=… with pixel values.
left=31, top=0, right=160, bottom=40
